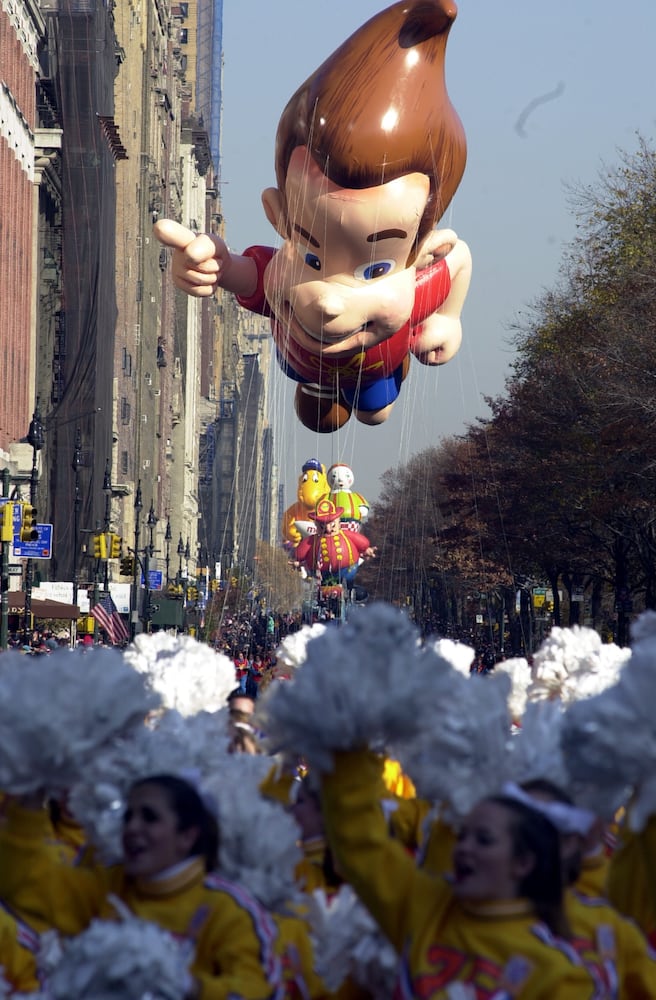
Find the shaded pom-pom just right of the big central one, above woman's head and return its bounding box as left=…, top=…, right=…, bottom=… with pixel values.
left=393, top=670, right=511, bottom=820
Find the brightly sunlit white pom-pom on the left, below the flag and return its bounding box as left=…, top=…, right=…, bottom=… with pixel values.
left=125, top=632, right=237, bottom=715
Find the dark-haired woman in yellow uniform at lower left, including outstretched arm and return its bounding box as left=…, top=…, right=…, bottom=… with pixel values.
left=0, top=774, right=279, bottom=1000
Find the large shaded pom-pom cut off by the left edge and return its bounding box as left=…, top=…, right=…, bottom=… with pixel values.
left=0, top=649, right=160, bottom=796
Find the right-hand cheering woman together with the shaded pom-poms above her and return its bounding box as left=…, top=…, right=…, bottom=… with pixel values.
left=261, top=604, right=603, bottom=1000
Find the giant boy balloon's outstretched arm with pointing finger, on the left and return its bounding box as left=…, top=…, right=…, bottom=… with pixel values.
left=153, top=219, right=257, bottom=298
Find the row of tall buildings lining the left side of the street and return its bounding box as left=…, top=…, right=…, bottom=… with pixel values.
left=0, top=0, right=277, bottom=627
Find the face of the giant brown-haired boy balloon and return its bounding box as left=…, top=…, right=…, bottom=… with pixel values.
left=264, top=147, right=429, bottom=356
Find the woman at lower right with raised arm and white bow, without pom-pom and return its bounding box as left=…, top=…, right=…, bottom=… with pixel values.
left=322, top=751, right=604, bottom=1000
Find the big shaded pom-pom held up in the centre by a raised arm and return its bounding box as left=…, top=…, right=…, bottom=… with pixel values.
left=257, top=604, right=444, bottom=771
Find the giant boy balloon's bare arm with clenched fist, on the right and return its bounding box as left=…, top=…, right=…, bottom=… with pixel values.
left=410, top=230, right=472, bottom=365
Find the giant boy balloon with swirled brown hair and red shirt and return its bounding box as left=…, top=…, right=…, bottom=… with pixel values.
left=155, top=0, right=471, bottom=432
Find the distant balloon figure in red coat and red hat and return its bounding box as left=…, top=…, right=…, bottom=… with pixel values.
left=294, top=497, right=376, bottom=590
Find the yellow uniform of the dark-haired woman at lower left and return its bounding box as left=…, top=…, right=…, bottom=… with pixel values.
left=0, top=803, right=280, bottom=1000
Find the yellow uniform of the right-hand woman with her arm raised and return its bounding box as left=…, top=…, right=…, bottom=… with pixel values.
left=322, top=751, right=596, bottom=1000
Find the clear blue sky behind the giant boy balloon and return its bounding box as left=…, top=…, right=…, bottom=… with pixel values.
left=222, top=0, right=656, bottom=502
